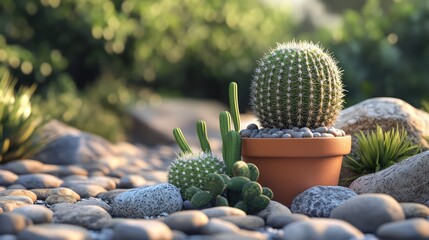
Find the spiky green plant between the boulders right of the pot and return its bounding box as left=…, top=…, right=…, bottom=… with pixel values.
left=344, top=125, right=421, bottom=180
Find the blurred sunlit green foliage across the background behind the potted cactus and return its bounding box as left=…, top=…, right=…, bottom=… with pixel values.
left=0, top=0, right=429, bottom=140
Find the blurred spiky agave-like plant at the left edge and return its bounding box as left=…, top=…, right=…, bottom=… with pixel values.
left=0, top=72, right=45, bottom=163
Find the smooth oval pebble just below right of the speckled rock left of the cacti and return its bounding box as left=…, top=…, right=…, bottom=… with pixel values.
left=162, top=210, right=209, bottom=233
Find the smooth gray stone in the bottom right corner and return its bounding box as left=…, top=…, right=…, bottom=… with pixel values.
left=377, top=219, right=429, bottom=240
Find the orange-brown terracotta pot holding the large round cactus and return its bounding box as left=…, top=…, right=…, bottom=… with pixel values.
left=242, top=136, right=351, bottom=207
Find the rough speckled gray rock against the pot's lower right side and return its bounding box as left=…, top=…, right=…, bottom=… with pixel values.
left=290, top=186, right=357, bottom=218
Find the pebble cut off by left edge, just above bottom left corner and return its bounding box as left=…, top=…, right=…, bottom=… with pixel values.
left=0, top=213, right=33, bottom=235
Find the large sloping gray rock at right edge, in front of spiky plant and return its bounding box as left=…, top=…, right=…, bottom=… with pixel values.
left=350, top=150, right=429, bottom=203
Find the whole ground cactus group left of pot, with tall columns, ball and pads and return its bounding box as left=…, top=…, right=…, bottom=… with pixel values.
left=168, top=82, right=273, bottom=213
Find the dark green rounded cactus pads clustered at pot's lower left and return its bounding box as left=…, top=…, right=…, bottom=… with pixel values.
left=185, top=161, right=273, bottom=213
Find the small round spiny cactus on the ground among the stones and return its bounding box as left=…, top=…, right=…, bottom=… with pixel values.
left=168, top=152, right=225, bottom=194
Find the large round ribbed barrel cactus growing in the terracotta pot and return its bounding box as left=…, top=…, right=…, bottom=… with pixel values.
left=250, top=42, right=344, bottom=129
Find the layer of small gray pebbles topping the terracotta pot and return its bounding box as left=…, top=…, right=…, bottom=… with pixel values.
left=240, top=123, right=346, bottom=138
